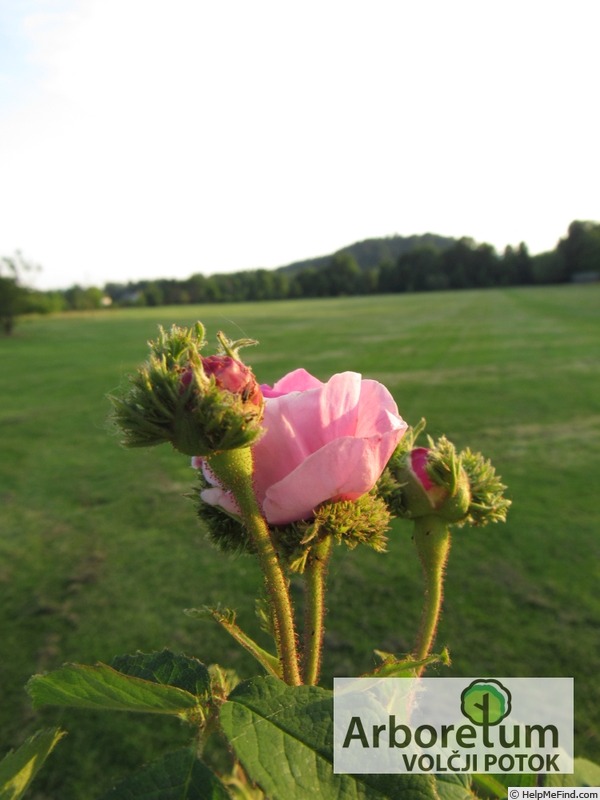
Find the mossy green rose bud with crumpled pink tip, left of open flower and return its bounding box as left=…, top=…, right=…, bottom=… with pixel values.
left=111, top=323, right=263, bottom=456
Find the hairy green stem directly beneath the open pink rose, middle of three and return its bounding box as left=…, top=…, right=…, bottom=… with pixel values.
left=302, top=536, right=333, bottom=686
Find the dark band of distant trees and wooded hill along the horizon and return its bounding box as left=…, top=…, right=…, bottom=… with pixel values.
left=0, top=221, right=600, bottom=333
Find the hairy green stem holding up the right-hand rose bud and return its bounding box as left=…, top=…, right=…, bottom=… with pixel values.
left=414, top=516, right=450, bottom=675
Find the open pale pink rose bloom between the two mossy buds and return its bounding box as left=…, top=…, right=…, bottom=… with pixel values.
left=197, top=369, right=407, bottom=525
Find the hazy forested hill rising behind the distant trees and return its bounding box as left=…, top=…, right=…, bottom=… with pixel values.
left=277, top=233, right=456, bottom=274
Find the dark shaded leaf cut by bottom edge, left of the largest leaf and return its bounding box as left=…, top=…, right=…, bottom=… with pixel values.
left=100, top=748, right=230, bottom=800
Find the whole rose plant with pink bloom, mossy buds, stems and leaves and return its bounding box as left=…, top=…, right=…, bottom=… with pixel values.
left=11, top=323, right=592, bottom=800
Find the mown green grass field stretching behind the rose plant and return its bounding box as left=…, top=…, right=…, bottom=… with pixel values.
left=0, top=286, right=600, bottom=800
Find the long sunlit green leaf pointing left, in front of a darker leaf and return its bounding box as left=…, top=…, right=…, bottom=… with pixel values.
left=27, top=664, right=202, bottom=719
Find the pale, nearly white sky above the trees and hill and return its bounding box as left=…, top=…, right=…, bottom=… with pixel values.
left=0, top=0, right=600, bottom=289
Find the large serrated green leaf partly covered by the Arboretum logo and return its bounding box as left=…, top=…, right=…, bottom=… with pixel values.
left=220, top=677, right=438, bottom=800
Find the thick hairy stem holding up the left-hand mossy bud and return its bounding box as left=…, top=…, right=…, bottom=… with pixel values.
left=209, top=447, right=301, bottom=686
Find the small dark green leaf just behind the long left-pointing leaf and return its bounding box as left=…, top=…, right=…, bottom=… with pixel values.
left=111, top=650, right=210, bottom=696
